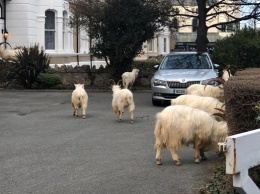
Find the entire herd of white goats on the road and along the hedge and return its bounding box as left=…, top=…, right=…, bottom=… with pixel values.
left=71, top=66, right=234, bottom=165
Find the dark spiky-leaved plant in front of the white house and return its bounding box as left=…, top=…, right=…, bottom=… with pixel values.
left=12, top=44, right=50, bottom=88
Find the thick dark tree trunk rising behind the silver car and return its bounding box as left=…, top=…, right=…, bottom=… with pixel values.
left=196, top=0, right=209, bottom=52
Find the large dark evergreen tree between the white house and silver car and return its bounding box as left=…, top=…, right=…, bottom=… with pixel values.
left=72, top=0, right=172, bottom=80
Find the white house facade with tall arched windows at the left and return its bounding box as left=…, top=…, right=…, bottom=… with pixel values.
left=0, top=0, right=89, bottom=64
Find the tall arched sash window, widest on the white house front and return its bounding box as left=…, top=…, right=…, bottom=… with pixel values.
left=45, top=11, right=55, bottom=50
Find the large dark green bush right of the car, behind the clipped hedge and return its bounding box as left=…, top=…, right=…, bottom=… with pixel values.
left=212, top=28, right=260, bottom=72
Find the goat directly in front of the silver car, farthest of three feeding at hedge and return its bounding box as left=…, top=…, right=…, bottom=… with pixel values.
left=187, top=78, right=225, bottom=102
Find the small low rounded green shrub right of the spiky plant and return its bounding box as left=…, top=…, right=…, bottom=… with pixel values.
left=36, top=73, right=62, bottom=89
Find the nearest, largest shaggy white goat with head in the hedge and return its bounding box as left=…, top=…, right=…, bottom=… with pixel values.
left=154, top=105, right=228, bottom=165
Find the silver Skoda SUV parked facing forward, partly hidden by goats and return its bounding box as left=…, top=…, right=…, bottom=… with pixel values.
left=151, top=52, right=219, bottom=105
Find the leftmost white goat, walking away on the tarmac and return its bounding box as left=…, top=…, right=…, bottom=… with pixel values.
left=71, top=84, right=88, bottom=119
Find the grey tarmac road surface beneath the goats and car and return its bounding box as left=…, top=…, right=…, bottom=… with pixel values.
left=0, top=90, right=216, bottom=194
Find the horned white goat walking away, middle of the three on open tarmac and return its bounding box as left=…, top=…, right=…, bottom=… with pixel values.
left=112, top=80, right=135, bottom=123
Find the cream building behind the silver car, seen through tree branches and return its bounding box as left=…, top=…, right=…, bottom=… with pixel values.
left=139, top=0, right=240, bottom=58
